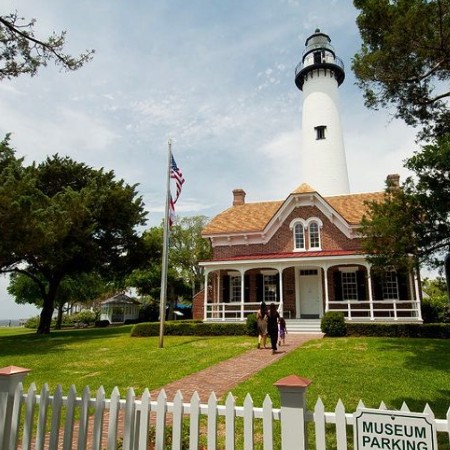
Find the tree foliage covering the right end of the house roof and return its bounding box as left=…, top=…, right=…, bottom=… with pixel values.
left=361, top=136, right=450, bottom=268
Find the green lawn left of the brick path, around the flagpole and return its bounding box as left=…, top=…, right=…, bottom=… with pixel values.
left=0, top=325, right=254, bottom=395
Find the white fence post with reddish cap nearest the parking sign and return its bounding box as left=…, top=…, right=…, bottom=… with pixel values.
left=274, top=375, right=311, bottom=450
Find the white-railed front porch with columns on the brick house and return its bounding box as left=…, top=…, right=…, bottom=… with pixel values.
left=194, top=254, right=422, bottom=331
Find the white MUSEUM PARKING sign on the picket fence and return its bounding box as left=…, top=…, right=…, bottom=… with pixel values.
left=354, top=408, right=437, bottom=450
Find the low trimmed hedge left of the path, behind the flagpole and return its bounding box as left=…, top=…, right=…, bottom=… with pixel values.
left=131, top=320, right=248, bottom=337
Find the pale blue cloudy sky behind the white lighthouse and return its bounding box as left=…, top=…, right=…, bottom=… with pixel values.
left=0, top=0, right=422, bottom=319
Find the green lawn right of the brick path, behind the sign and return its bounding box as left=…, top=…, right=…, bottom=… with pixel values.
left=233, top=337, right=450, bottom=419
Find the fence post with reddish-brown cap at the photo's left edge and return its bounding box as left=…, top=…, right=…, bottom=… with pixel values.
left=0, top=366, right=30, bottom=449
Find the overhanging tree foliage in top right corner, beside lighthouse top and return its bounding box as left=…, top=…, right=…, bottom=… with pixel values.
left=352, top=0, right=450, bottom=138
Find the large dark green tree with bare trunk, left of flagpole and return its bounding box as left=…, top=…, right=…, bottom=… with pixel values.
left=0, top=146, right=146, bottom=333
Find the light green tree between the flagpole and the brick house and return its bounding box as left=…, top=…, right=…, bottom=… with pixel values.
left=169, top=216, right=211, bottom=297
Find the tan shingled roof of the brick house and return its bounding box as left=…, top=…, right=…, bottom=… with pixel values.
left=202, top=183, right=384, bottom=236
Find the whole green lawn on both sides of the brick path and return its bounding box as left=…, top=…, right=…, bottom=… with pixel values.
left=0, top=326, right=450, bottom=418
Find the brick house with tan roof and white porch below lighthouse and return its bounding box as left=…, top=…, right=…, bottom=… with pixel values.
left=193, top=183, right=421, bottom=323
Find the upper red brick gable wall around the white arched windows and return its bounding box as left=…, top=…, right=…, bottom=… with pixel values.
left=213, top=206, right=361, bottom=259
